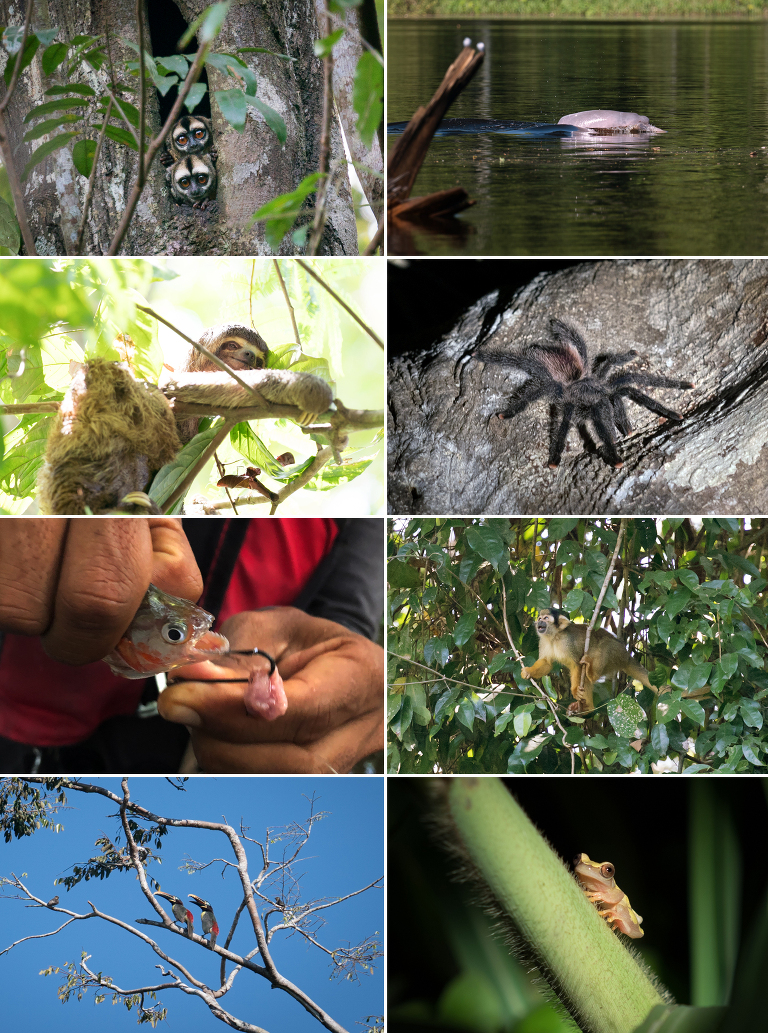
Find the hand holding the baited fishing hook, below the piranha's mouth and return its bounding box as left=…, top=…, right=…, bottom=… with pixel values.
left=157, top=606, right=383, bottom=775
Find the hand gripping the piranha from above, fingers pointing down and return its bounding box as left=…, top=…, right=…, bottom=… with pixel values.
left=0, top=517, right=203, bottom=664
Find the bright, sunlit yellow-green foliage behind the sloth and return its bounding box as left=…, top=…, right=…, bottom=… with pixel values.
left=0, top=259, right=383, bottom=513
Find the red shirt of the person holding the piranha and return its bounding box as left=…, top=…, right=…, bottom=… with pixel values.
left=0, top=519, right=337, bottom=746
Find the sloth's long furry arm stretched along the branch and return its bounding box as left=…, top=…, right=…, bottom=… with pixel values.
left=160, top=370, right=333, bottom=425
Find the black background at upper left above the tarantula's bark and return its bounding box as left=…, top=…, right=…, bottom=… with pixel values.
left=387, top=258, right=578, bottom=357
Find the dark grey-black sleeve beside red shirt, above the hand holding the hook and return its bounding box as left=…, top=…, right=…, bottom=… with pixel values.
left=294, top=517, right=385, bottom=638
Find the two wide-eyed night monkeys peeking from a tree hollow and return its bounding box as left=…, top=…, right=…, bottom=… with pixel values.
left=160, top=115, right=218, bottom=209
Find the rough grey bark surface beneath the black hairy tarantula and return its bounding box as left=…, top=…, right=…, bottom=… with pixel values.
left=389, top=259, right=768, bottom=515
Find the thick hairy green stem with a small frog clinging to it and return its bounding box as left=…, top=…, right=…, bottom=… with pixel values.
left=448, top=778, right=668, bottom=1033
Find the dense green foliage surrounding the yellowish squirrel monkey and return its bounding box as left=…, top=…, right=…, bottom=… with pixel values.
left=388, top=518, right=768, bottom=773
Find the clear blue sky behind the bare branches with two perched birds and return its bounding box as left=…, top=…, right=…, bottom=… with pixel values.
left=0, top=776, right=383, bottom=1033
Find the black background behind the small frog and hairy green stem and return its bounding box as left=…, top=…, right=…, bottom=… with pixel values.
left=388, top=775, right=768, bottom=1033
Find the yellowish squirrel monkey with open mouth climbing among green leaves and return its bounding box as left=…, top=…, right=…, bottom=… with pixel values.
left=520, top=606, right=656, bottom=714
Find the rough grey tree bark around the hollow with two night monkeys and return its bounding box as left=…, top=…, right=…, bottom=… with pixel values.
left=0, top=0, right=358, bottom=255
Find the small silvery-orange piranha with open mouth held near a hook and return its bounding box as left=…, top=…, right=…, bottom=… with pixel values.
left=104, top=585, right=229, bottom=679
